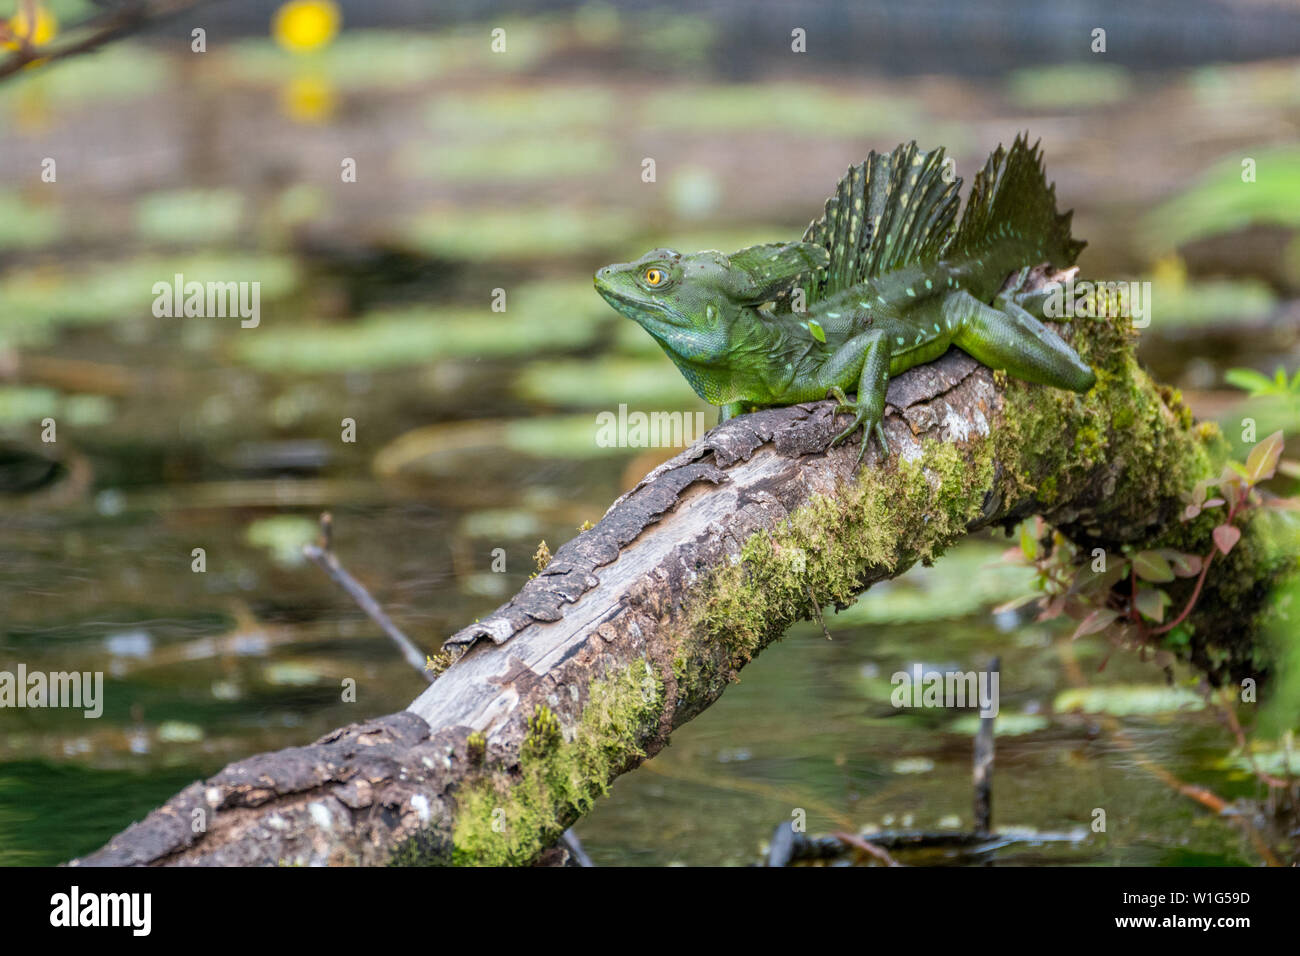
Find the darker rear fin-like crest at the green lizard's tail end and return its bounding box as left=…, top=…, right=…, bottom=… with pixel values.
left=949, top=134, right=1087, bottom=269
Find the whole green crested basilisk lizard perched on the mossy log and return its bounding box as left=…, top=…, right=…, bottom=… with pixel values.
left=595, top=137, right=1096, bottom=462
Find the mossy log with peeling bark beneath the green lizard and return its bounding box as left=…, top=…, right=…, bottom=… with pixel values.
left=77, top=273, right=1277, bottom=865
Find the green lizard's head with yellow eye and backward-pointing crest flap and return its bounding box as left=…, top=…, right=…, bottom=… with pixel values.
left=595, top=242, right=828, bottom=362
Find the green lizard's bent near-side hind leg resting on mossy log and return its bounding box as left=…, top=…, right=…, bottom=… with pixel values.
left=944, top=291, right=1097, bottom=392
